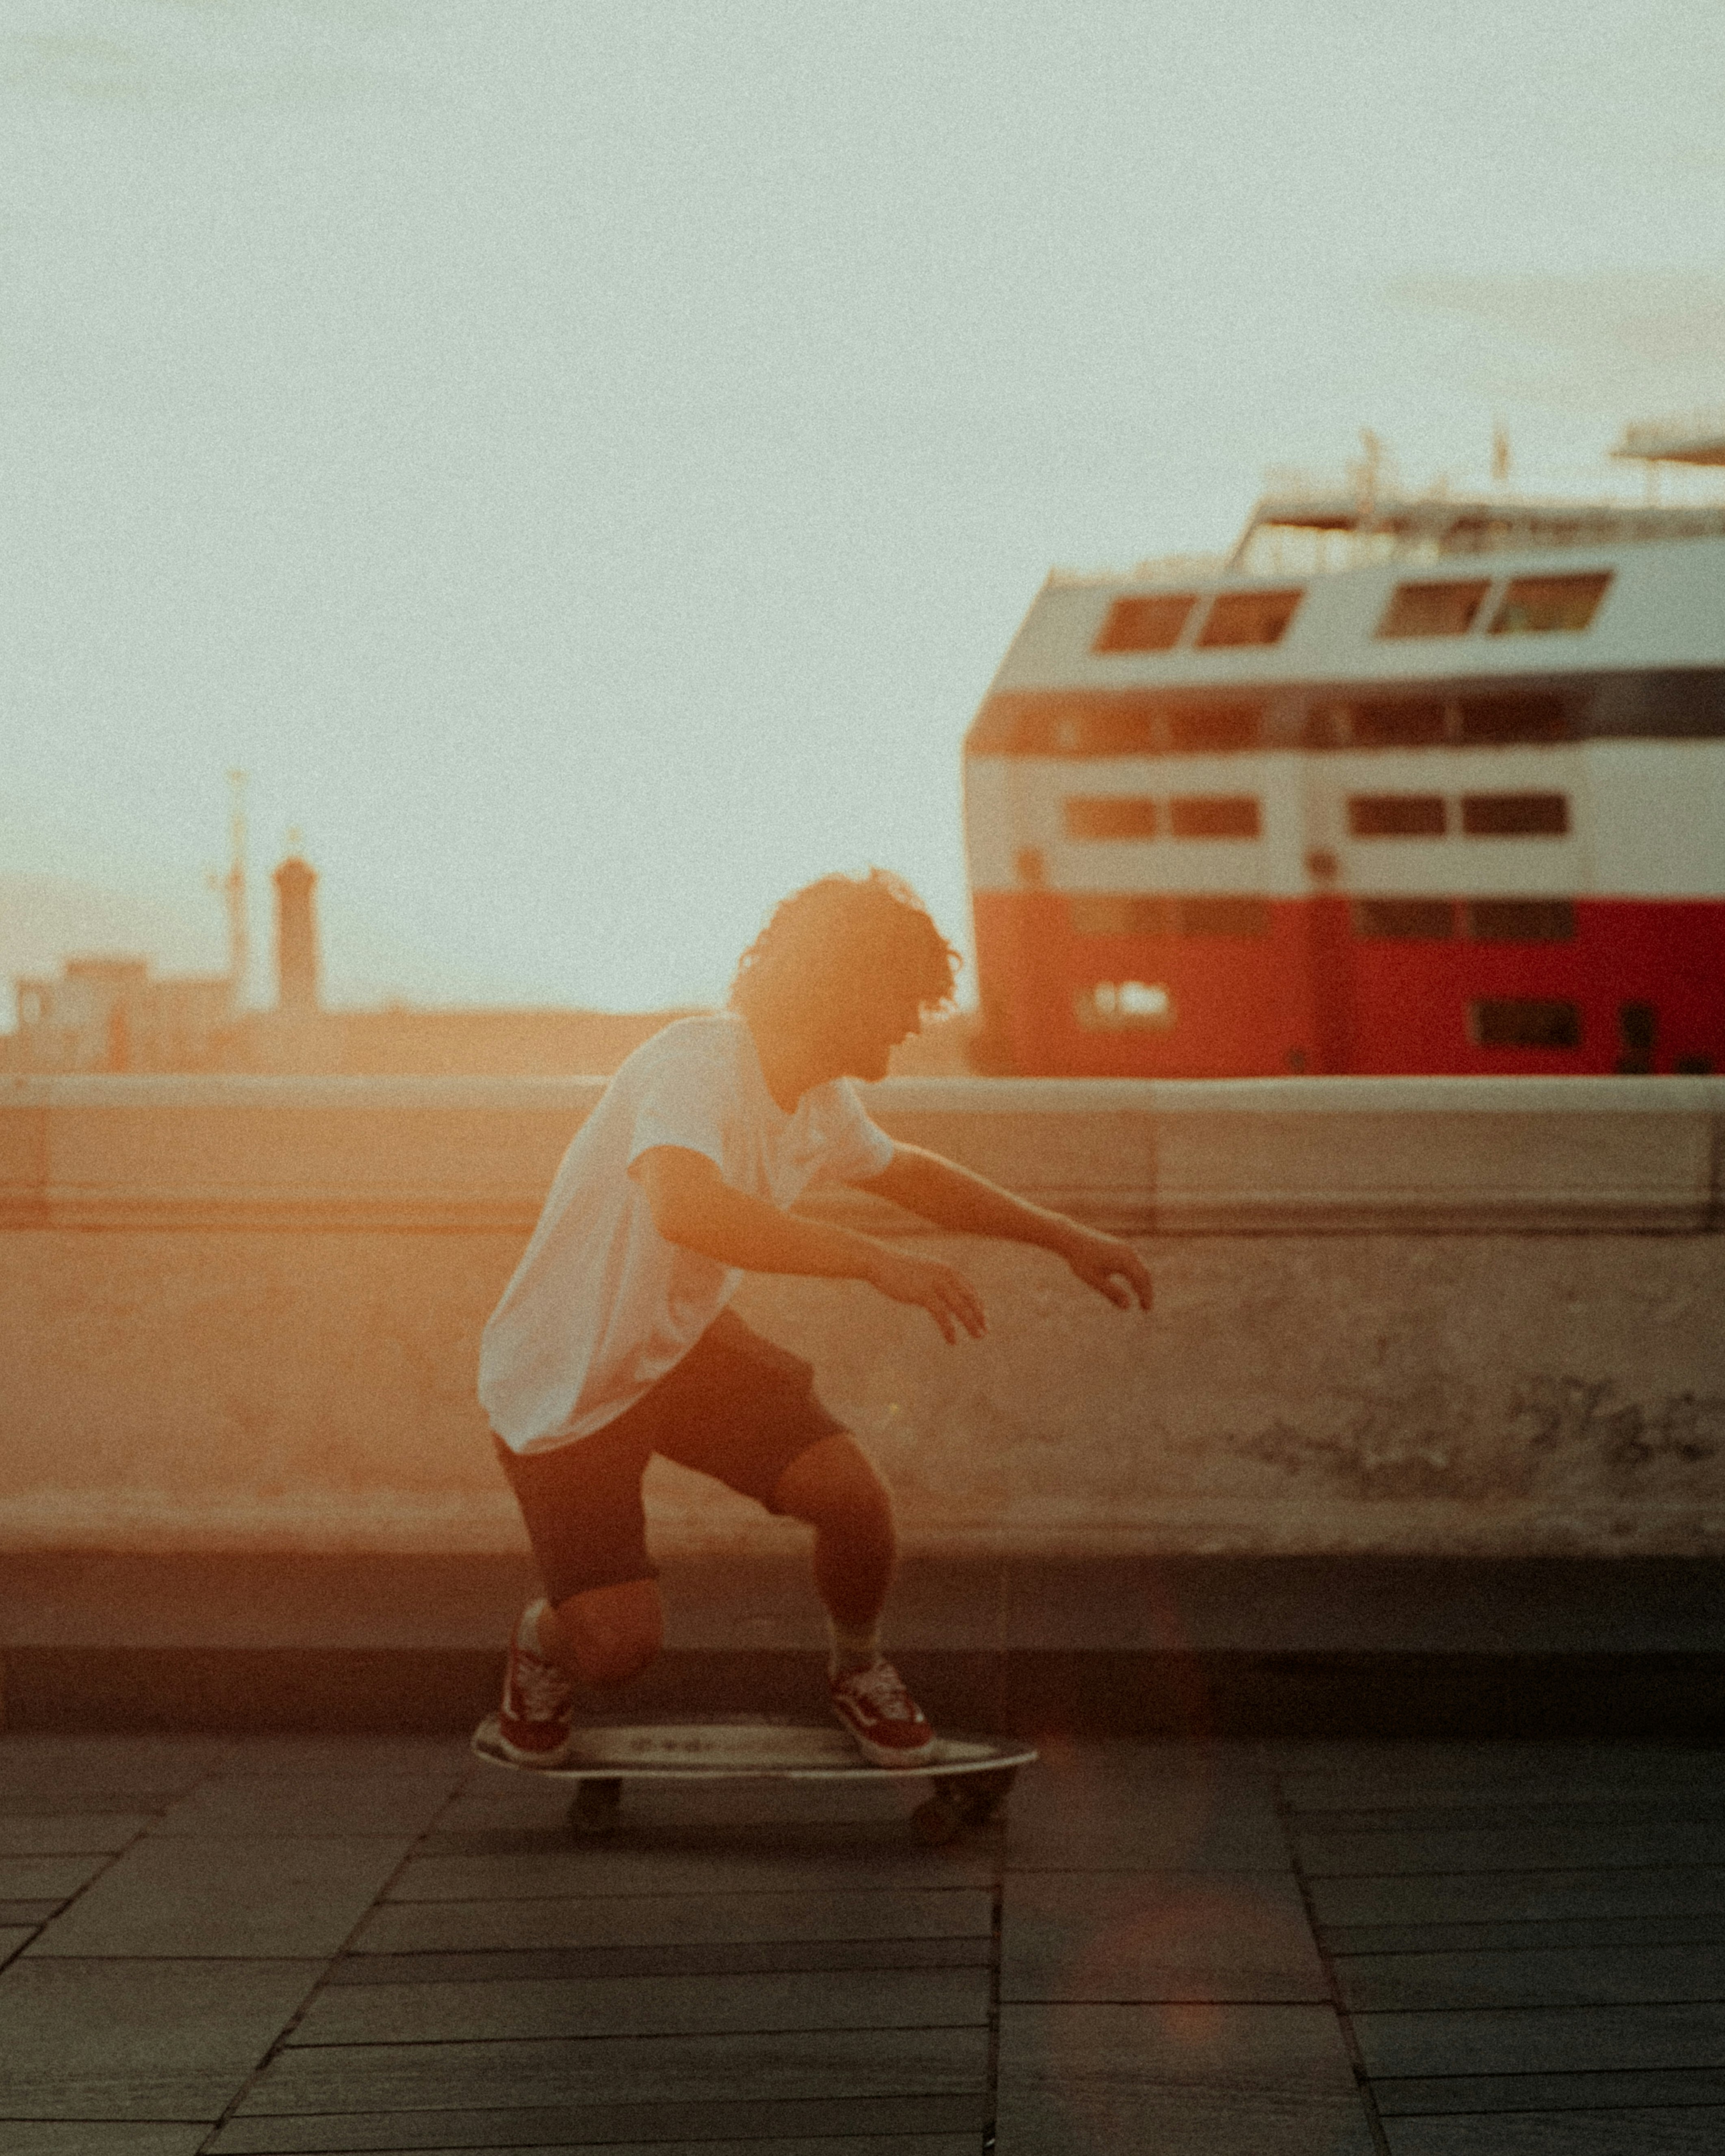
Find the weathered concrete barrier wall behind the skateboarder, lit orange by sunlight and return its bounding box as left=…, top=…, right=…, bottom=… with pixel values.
left=0, top=1078, right=1725, bottom=1555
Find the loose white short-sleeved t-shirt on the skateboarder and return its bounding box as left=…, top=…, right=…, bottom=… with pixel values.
left=479, top=1015, right=893, bottom=1453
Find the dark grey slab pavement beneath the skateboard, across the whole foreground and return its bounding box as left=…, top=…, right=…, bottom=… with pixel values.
left=0, top=1733, right=1725, bottom=2156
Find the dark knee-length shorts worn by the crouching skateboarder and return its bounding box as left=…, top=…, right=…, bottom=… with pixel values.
left=494, top=1311, right=845, bottom=1604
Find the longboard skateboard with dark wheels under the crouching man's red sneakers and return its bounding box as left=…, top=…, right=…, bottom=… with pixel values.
left=472, top=1714, right=1035, bottom=1846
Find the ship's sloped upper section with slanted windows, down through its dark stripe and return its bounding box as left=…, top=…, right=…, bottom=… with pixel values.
left=970, top=481, right=1725, bottom=755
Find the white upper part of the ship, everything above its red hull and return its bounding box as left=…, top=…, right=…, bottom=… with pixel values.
left=966, top=427, right=1725, bottom=918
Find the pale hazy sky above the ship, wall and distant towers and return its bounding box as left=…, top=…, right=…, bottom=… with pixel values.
left=0, top=0, right=1725, bottom=1007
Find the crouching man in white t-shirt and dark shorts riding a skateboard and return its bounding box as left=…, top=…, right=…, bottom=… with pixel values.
left=479, top=869, right=1152, bottom=1768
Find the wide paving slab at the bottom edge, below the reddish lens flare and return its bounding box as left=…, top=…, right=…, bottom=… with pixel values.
left=998, top=2005, right=1373, bottom=2156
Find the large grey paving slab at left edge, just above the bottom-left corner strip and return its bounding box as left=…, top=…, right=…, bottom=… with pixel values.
left=0, top=1958, right=315, bottom=2121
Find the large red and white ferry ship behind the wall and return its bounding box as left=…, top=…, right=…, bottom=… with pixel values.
left=964, top=418, right=1725, bottom=1078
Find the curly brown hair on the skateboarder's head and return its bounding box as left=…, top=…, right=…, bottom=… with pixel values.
left=731, top=869, right=962, bottom=1033
